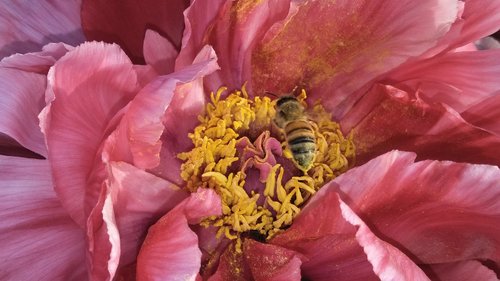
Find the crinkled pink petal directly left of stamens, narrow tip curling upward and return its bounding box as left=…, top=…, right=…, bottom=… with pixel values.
left=105, top=47, right=218, bottom=184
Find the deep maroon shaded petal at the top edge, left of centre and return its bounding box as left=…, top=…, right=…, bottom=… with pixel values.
left=81, top=0, right=189, bottom=63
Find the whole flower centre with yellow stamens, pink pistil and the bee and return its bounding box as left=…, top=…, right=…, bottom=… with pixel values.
left=178, top=86, right=355, bottom=250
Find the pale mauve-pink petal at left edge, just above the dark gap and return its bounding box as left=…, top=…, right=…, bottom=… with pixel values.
left=0, top=66, right=47, bottom=156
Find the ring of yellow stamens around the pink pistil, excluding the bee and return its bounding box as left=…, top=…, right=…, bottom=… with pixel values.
left=178, top=86, right=354, bottom=252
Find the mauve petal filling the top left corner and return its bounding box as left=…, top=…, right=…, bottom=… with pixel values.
left=0, top=0, right=85, bottom=58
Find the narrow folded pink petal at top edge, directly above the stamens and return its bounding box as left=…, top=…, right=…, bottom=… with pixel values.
left=176, top=0, right=290, bottom=90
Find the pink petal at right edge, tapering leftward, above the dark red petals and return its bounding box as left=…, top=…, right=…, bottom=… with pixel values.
left=387, top=50, right=500, bottom=112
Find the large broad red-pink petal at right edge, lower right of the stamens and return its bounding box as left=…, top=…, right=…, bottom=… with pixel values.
left=334, top=151, right=500, bottom=264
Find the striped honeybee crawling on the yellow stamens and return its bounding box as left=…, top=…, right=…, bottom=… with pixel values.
left=274, top=95, right=316, bottom=173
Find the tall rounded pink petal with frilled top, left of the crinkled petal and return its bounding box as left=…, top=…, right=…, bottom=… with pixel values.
left=40, top=42, right=137, bottom=225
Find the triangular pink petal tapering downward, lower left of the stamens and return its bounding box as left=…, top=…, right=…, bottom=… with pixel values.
left=109, top=162, right=187, bottom=266
